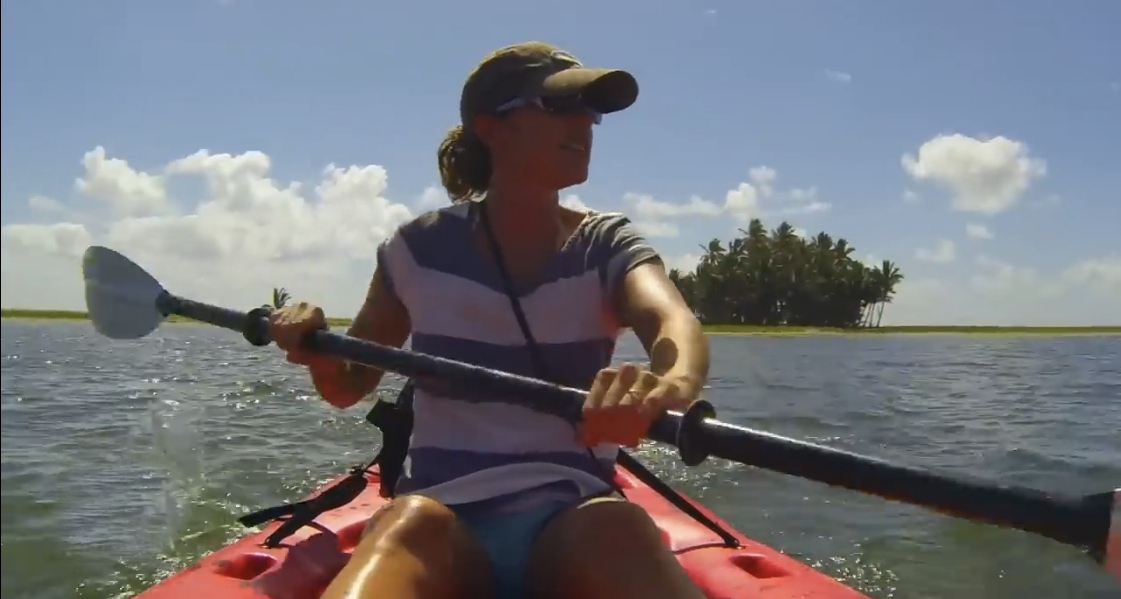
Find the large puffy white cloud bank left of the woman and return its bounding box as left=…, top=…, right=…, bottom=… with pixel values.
left=2, top=147, right=413, bottom=315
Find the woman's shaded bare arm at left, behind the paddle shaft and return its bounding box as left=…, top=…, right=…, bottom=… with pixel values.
left=311, top=264, right=413, bottom=408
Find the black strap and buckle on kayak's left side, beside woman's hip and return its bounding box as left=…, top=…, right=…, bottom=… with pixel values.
left=238, top=381, right=413, bottom=547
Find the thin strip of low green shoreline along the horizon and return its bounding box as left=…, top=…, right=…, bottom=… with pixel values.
left=0, top=308, right=1121, bottom=337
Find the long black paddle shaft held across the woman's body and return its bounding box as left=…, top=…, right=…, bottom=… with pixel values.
left=157, top=293, right=1114, bottom=563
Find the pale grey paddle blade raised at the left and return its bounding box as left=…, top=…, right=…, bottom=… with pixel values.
left=82, top=246, right=165, bottom=339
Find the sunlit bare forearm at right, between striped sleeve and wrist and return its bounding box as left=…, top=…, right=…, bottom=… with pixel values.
left=619, top=260, right=708, bottom=409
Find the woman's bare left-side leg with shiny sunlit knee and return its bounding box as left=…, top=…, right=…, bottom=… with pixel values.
left=322, top=496, right=492, bottom=599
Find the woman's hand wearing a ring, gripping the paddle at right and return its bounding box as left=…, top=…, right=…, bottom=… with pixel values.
left=577, top=363, right=700, bottom=448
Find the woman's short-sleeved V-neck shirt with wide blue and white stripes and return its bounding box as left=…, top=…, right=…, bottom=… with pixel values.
left=378, top=202, right=659, bottom=505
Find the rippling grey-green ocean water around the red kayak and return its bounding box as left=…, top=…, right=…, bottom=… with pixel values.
left=0, top=320, right=1121, bottom=599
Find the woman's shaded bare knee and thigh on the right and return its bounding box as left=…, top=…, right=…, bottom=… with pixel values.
left=529, top=497, right=704, bottom=599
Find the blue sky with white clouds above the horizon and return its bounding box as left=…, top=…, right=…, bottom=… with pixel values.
left=0, top=0, right=1121, bottom=325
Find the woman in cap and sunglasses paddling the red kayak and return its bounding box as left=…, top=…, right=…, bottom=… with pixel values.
left=271, top=43, right=708, bottom=599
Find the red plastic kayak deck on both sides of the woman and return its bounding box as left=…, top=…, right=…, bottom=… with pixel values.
left=131, top=468, right=868, bottom=599
